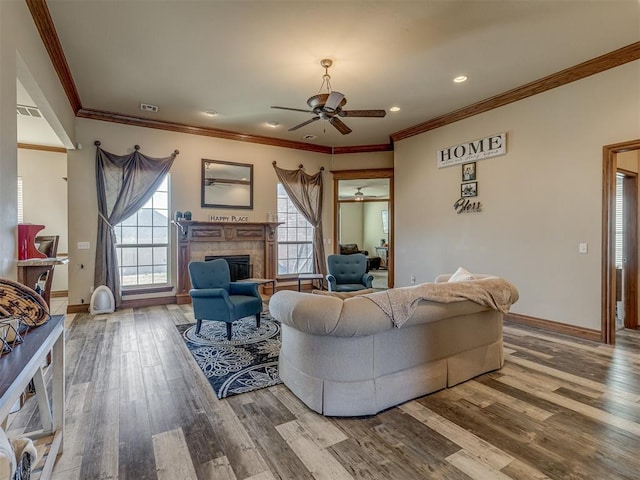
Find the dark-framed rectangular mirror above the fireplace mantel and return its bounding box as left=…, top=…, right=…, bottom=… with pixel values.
left=201, top=158, right=253, bottom=210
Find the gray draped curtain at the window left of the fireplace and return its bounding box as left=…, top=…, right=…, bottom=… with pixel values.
left=94, top=142, right=178, bottom=306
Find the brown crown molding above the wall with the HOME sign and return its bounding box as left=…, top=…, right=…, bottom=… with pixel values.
left=391, top=42, right=640, bottom=142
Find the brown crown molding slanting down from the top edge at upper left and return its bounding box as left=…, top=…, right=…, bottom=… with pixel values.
left=26, top=0, right=82, bottom=113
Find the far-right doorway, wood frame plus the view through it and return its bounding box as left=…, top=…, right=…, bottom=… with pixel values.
left=601, top=139, right=640, bottom=344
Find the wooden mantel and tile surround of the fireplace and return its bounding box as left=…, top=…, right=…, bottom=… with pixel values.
left=173, top=221, right=279, bottom=304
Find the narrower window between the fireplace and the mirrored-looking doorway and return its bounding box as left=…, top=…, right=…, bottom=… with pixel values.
left=278, top=183, right=313, bottom=276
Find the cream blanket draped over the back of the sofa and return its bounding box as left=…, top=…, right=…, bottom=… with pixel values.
left=362, top=277, right=518, bottom=328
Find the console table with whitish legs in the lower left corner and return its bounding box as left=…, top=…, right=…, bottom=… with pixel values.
left=0, top=315, right=65, bottom=480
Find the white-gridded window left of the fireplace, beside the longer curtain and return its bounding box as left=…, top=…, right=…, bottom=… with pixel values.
left=115, top=176, right=169, bottom=287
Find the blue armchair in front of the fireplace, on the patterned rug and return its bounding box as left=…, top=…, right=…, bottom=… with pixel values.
left=189, top=258, right=262, bottom=340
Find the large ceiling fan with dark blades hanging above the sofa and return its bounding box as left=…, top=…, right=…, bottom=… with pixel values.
left=271, top=58, right=387, bottom=135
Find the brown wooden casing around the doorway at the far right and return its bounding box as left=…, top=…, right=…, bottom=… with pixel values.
left=600, top=139, right=640, bottom=345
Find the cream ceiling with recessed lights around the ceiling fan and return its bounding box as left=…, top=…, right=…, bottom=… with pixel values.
left=17, top=0, right=640, bottom=146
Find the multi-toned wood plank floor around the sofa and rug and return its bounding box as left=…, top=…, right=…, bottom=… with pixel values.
left=11, top=305, right=640, bottom=480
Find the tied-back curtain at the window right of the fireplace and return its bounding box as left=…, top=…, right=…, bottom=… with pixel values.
left=273, top=162, right=327, bottom=275
